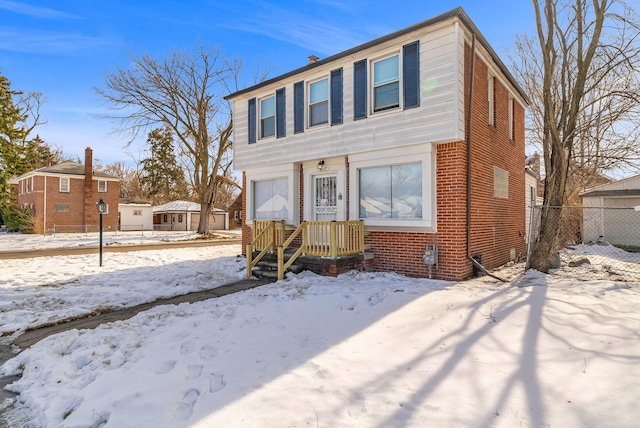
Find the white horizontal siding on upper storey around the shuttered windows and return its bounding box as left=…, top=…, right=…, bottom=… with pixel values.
left=233, top=25, right=465, bottom=170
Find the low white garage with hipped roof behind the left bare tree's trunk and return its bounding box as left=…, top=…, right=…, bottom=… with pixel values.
left=153, top=201, right=229, bottom=231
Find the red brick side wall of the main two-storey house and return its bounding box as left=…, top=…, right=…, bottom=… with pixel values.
left=465, top=46, right=526, bottom=269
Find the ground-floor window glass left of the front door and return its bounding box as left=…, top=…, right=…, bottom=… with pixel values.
left=252, top=178, right=289, bottom=220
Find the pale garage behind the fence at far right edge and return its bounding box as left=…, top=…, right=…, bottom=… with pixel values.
left=580, top=175, right=640, bottom=248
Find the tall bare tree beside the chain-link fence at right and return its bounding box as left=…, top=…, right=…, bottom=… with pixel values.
left=518, top=0, right=638, bottom=272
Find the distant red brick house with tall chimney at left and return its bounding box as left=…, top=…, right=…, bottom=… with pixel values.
left=17, top=147, right=120, bottom=233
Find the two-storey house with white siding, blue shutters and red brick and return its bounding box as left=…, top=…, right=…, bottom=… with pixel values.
left=226, top=8, right=528, bottom=280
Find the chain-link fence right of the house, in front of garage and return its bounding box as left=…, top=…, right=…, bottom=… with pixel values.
left=527, top=206, right=640, bottom=282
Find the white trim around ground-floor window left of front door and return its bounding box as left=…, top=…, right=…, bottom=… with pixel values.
left=245, top=163, right=300, bottom=227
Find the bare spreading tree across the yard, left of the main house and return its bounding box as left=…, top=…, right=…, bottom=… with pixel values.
left=96, top=47, right=241, bottom=234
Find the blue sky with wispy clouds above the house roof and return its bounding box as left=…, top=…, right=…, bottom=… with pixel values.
left=0, top=0, right=534, bottom=165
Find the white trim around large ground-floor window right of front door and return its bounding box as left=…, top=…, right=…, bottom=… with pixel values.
left=349, top=143, right=436, bottom=232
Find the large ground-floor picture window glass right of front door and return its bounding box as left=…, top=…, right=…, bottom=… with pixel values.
left=358, top=163, right=422, bottom=220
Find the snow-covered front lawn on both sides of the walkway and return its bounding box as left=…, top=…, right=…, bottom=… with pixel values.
left=0, top=237, right=640, bottom=428
